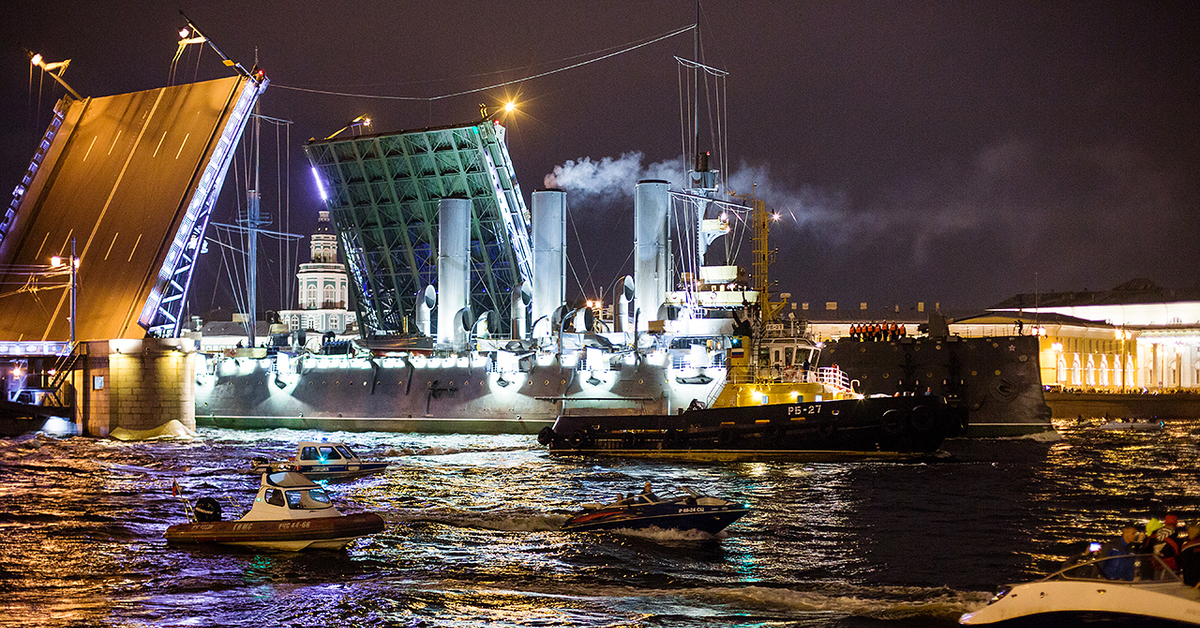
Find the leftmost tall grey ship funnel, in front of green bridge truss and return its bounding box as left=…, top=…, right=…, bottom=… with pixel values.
left=438, top=198, right=470, bottom=351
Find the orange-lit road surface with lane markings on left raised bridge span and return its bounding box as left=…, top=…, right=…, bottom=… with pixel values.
left=0, top=77, right=246, bottom=340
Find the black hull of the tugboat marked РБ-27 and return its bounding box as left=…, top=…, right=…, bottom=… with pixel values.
left=538, top=396, right=967, bottom=461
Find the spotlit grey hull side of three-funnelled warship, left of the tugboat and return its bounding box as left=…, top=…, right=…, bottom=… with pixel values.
left=196, top=357, right=725, bottom=435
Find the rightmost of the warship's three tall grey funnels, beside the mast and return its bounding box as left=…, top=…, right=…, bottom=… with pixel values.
left=634, top=180, right=671, bottom=330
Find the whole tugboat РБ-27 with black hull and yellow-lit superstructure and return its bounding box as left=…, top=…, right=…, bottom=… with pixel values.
left=538, top=193, right=968, bottom=460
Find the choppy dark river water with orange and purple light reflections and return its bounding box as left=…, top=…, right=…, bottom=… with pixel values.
left=0, top=423, right=1200, bottom=627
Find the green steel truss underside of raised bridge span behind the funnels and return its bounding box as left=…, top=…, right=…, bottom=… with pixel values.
left=305, top=120, right=532, bottom=336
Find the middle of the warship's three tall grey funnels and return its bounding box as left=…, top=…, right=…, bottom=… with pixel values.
left=530, top=190, right=566, bottom=336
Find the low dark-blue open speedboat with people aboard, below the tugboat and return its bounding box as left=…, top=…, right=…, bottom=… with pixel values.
left=563, top=488, right=750, bottom=534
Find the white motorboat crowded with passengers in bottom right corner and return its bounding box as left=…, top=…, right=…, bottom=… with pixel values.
left=959, top=555, right=1200, bottom=624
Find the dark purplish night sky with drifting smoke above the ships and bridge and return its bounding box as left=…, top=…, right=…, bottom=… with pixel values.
left=0, top=0, right=1200, bottom=311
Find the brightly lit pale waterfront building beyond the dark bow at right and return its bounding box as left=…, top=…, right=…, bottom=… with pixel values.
left=794, top=279, right=1200, bottom=393
